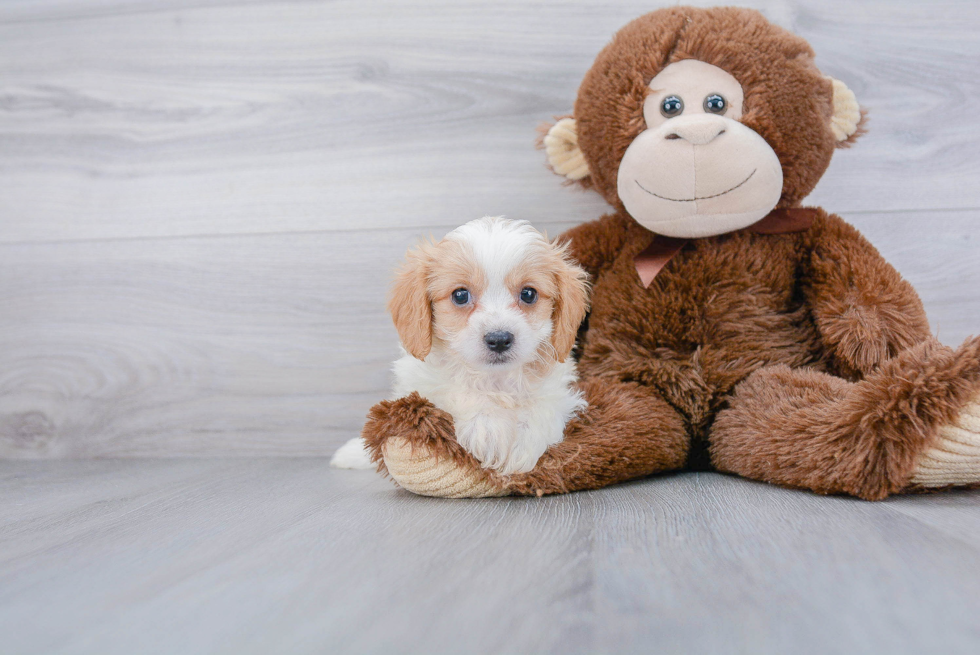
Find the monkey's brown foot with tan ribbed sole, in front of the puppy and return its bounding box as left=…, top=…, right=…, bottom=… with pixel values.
left=361, top=391, right=508, bottom=498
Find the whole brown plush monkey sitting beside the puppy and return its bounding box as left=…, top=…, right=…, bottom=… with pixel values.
left=363, top=7, right=980, bottom=500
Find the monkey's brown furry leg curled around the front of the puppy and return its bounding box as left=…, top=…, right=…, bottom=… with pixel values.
left=363, top=380, right=689, bottom=498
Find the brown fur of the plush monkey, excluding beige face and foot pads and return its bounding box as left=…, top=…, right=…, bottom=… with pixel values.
left=365, top=7, right=980, bottom=499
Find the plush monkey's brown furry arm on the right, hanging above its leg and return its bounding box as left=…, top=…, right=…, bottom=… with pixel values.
left=803, top=210, right=931, bottom=376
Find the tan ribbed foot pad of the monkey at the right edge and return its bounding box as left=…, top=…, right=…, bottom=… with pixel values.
left=912, top=396, right=980, bottom=487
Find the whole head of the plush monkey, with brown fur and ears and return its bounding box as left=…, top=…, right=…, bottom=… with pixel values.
left=542, top=7, right=865, bottom=238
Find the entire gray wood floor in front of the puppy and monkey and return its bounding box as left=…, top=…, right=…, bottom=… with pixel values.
left=0, top=458, right=980, bottom=655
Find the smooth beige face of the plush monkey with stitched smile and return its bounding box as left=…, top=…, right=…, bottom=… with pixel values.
left=617, top=59, right=783, bottom=238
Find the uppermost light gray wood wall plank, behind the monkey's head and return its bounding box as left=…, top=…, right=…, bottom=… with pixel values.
left=0, top=0, right=980, bottom=242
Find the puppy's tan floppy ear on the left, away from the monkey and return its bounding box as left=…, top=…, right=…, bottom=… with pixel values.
left=388, top=246, right=432, bottom=360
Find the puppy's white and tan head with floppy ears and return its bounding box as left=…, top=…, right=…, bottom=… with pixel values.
left=389, top=218, right=588, bottom=369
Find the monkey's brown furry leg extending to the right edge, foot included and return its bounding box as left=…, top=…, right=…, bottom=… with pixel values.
left=709, top=338, right=980, bottom=500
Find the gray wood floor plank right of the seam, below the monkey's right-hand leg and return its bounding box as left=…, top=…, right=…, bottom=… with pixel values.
left=594, top=474, right=980, bottom=654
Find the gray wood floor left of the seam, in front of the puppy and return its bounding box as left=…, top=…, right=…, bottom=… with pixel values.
left=0, top=458, right=589, bottom=653
